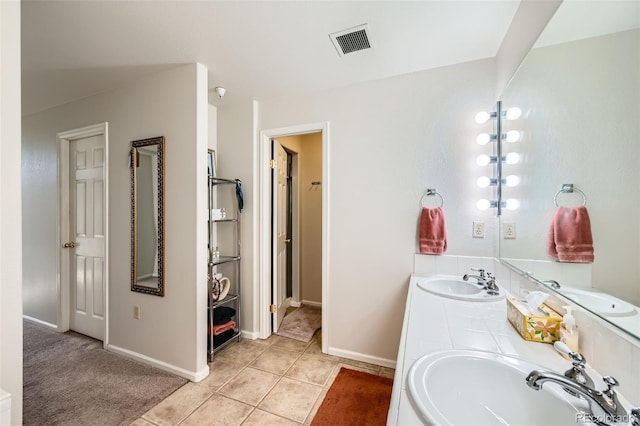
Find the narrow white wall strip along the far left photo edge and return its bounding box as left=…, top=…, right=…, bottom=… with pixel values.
left=0, top=1, right=22, bottom=425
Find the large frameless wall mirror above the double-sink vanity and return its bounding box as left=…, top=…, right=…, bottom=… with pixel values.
left=500, top=0, right=640, bottom=338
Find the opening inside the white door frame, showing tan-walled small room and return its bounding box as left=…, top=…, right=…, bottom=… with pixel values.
left=271, top=132, right=322, bottom=333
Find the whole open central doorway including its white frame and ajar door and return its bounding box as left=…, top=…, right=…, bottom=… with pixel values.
left=258, top=123, right=329, bottom=353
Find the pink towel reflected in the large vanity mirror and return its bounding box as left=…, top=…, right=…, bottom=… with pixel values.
left=547, top=206, right=594, bottom=263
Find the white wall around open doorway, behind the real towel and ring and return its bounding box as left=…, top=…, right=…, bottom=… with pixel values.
left=218, top=60, right=497, bottom=360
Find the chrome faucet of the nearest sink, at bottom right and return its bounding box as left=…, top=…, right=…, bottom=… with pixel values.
left=526, top=342, right=640, bottom=426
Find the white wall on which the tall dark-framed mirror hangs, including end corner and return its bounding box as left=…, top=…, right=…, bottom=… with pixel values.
left=23, top=64, right=208, bottom=378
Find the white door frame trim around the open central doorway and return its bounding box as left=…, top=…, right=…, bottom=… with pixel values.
left=254, top=122, right=330, bottom=353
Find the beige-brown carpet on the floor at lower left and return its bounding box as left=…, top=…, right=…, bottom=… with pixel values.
left=23, top=321, right=187, bottom=426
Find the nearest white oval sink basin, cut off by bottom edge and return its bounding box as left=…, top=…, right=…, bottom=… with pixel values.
left=407, top=350, right=587, bottom=426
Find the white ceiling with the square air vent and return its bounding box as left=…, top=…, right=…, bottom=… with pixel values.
left=22, top=0, right=520, bottom=115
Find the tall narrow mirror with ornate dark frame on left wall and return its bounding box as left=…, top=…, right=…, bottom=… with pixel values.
left=129, top=137, right=164, bottom=296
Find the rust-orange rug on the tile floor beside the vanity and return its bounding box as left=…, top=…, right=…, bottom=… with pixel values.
left=311, top=367, right=393, bottom=426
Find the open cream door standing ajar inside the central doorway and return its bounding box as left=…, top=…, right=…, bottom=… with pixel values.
left=273, top=141, right=290, bottom=333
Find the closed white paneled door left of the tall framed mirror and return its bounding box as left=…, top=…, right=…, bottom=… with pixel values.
left=65, top=134, right=106, bottom=340
